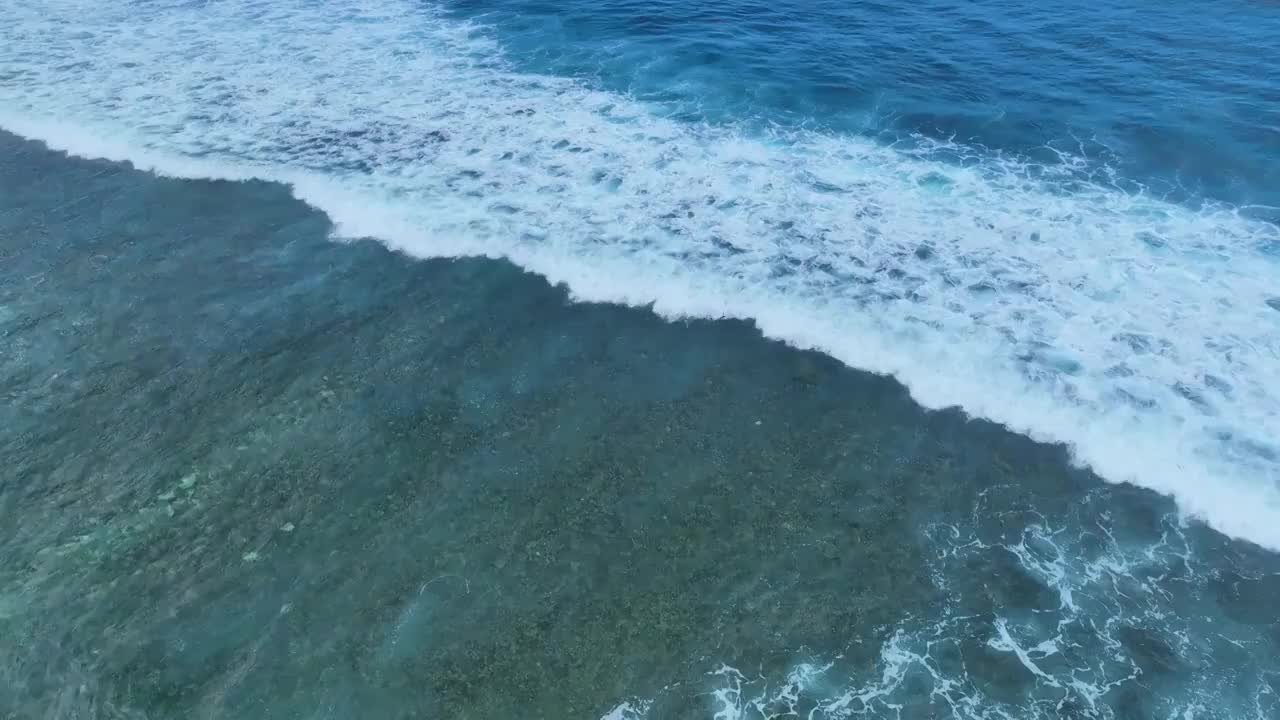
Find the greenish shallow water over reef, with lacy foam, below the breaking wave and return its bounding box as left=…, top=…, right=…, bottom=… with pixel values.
left=0, top=136, right=1280, bottom=719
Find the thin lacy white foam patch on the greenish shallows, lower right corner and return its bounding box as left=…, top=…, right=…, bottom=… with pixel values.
left=614, top=509, right=1280, bottom=720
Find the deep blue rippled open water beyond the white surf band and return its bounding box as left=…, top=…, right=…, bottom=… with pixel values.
left=447, top=0, right=1280, bottom=207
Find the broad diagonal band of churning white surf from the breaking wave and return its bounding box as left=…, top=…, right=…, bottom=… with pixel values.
left=0, top=0, right=1280, bottom=548
